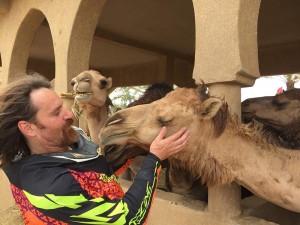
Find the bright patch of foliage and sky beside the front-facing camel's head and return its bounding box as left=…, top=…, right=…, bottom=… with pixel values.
left=109, top=86, right=148, bottom=112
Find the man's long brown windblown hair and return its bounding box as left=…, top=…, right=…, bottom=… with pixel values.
left=0, top=74, right=51, bottom=168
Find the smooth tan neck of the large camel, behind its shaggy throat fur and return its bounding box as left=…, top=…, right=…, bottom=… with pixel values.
left=207, top=126, right=300, bottom=212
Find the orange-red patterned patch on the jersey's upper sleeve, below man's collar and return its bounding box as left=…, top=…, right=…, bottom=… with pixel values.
left=69, top=169, right=124, bottom=199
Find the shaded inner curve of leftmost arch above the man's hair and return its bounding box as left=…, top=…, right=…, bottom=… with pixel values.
left=7, top=9, right=45, bottom=82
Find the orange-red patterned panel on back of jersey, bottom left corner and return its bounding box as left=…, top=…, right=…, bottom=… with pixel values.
left=10, top=184, right=68, bottom=225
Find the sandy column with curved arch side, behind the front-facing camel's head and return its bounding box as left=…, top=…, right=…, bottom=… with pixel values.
left=49, top=0, right=105, bottom=92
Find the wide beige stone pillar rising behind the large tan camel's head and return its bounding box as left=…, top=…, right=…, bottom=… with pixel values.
left=193, top=0, right=260, bottom=216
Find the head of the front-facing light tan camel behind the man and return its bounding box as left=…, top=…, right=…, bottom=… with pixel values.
left=71, top=70, right=112, bottom=107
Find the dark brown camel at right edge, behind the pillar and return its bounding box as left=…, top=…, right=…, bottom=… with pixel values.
left=242, top=89, right=300, bottom=149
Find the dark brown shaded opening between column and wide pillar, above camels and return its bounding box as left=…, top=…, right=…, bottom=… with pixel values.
left=90, top=0, right=195, bottom=86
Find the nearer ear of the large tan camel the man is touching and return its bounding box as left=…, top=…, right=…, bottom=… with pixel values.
left=199, top=98, right=223, bottom=120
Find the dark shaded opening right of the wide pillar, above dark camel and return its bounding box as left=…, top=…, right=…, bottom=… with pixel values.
left=257, top=0, right=300, bottom=76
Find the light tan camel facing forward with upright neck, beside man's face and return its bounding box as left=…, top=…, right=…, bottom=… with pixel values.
left=71, top=70, right=112, bottom=144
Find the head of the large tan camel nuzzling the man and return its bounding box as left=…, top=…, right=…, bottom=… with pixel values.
left=100, top=85, right=227, bottom=166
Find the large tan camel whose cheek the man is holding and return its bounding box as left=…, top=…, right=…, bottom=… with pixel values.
left=99, top=84, right=300, bottom=213
